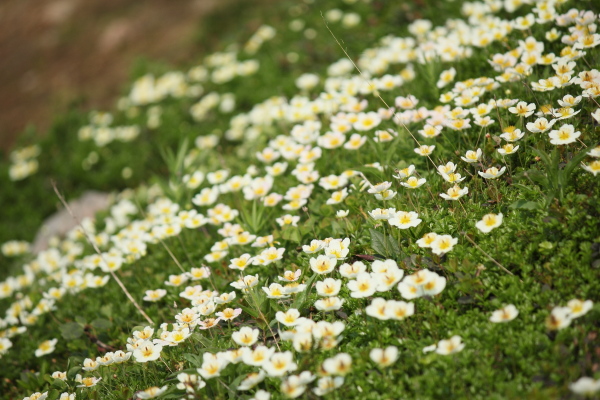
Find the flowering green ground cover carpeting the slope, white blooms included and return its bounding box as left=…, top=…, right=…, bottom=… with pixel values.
left=0, top=0, right=600, bottom=400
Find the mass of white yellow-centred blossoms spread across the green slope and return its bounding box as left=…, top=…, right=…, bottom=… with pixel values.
left=0, top=0, right=600, bottom=400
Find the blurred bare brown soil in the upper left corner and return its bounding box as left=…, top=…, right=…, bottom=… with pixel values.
left=0, top=0, right=230, bottom=150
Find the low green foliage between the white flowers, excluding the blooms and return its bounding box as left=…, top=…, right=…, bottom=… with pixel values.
left=0, top=0, right=600, bottom=399
